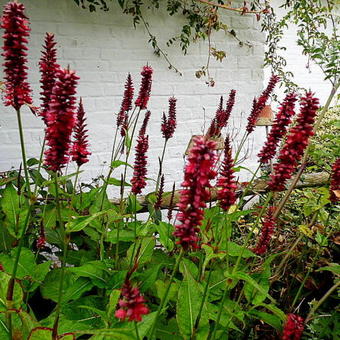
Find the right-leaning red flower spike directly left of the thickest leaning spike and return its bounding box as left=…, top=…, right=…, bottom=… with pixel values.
left=258, top=93, right=297, bottom=163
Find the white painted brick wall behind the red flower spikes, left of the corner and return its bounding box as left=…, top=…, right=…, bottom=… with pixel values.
left=0, top=0, right=264, bottom=191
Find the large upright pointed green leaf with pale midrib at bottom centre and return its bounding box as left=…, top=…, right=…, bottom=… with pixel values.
left=176, top=262, right=202, bottom=339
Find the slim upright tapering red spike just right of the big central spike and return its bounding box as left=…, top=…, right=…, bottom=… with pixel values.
left=217, top=137, right=237, bottom=211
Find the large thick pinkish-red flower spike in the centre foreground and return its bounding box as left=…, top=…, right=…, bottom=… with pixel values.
left=174, top=136, right=216, bottom=250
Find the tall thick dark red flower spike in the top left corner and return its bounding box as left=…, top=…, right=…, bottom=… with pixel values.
left=1, top=2, right=32, bottom=110
